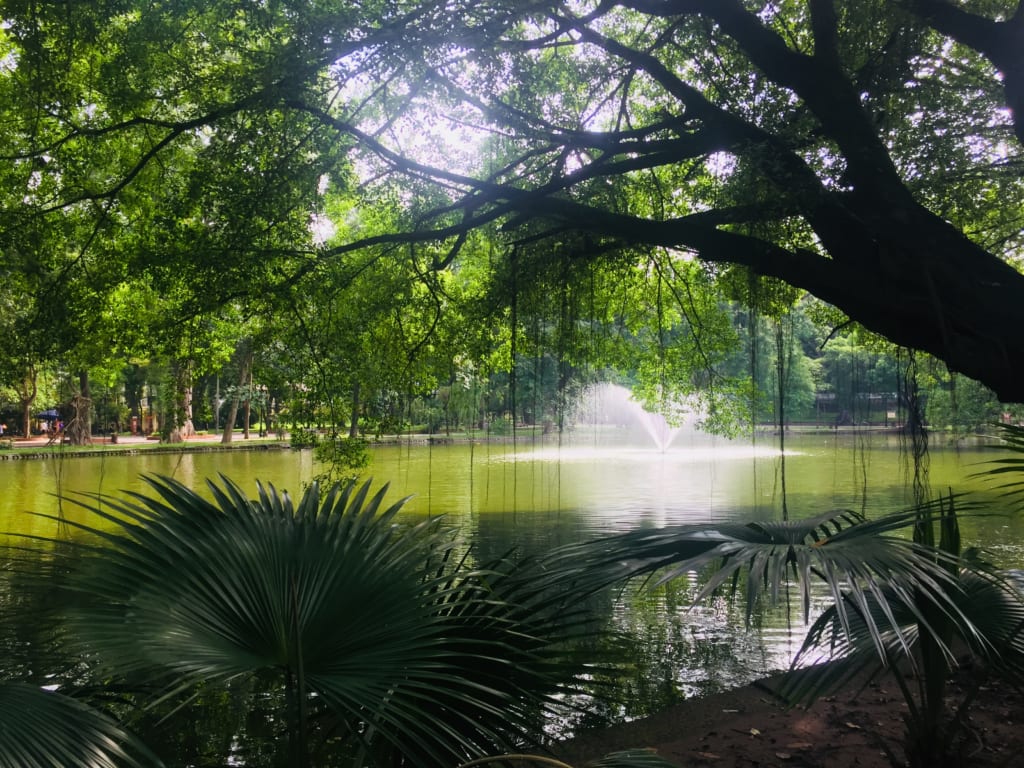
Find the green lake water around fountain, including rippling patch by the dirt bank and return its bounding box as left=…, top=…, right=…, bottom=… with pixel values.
left=0, top=427, right=1024, bottom=741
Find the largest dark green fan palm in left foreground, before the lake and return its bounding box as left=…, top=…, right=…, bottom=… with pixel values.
left=29, top=478, right=606, bottom=767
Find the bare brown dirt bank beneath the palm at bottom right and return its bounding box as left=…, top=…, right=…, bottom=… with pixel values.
left=555, top=667, right=1024, bottom=768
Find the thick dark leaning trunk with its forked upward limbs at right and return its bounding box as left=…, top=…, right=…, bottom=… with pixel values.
left=700, top=2, right=1024, bottom=401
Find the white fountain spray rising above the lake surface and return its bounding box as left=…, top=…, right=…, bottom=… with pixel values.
left=573, top=383, right=688, bottom=453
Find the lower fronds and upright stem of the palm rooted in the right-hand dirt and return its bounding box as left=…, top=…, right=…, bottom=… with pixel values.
left=781, top=498, right=1024, bottom=767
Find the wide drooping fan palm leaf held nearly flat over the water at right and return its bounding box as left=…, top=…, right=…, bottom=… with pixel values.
left=580, top=501, right=979, bottom=657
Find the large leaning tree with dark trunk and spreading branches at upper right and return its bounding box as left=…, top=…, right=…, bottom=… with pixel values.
left=315, top=0, right=1024, bottom=399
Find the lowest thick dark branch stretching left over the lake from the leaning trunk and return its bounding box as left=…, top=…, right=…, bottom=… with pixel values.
left=505, top=200, right=1024, bottom=401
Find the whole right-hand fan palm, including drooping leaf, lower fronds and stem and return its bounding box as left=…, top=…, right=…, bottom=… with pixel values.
left=583, top=499, right=1024, bottom=766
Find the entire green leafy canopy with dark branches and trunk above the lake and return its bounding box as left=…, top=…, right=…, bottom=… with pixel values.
left=0, top=0, right=1024, bottom=444
